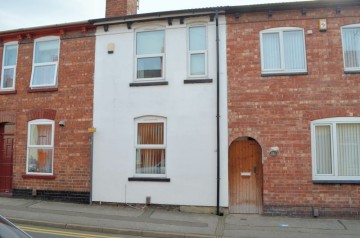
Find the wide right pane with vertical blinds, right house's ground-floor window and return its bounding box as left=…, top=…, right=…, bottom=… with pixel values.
left=336, top=124, right=360, bottom=176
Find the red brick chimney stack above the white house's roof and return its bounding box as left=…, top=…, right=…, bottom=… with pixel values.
left=105, top=0, right=138, bottom=18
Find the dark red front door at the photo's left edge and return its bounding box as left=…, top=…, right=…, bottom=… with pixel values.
left=0, top=123, right=15, bottom=194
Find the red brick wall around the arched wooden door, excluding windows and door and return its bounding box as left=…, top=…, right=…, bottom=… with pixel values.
left=227, top=7, right=360, bottom=215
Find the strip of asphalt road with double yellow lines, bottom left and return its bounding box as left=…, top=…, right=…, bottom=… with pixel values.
left=19, top=225, right=140, bottom=238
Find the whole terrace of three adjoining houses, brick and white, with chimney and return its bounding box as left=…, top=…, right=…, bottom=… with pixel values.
left=0, top=0, right=360, bottom=217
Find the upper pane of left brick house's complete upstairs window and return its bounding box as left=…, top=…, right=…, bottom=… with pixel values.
left=35, top=40, right=59, bottom=63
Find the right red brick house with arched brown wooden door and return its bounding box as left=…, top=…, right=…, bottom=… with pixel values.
left=227, top=0, right=360, bottom=217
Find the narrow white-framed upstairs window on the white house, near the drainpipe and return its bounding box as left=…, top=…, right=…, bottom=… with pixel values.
left=188, top=26, right=207, bottom=77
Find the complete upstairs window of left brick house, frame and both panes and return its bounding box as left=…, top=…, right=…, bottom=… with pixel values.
left=30, top=37, right=60, bottom=88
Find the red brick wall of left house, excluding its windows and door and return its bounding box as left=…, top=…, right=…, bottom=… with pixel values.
left=0, top=29, right=95, bottom=192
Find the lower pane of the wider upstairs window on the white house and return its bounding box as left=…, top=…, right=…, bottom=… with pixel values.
left=137, top=57, right=162, bottom=78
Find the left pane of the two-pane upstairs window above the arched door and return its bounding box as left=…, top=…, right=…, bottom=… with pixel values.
left=262, top=33, right=281, bottom=69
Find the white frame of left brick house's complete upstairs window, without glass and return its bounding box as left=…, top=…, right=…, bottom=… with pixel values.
left=30, top=36, right=60, bottom=88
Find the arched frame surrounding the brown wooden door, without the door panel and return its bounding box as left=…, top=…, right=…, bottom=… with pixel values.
left=228, top=137, right=264, bottom=214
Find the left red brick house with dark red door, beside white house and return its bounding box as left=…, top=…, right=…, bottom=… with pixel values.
left=0, top=22, right=95, bottom=202
